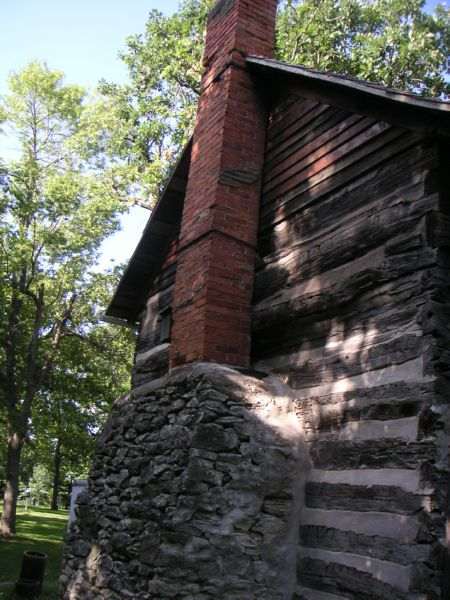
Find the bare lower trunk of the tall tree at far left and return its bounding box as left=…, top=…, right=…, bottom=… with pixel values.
left=0, top=433, right=23, bottom=537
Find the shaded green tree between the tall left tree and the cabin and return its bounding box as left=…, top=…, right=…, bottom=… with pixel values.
left=29, top=274, right=134, bottom=510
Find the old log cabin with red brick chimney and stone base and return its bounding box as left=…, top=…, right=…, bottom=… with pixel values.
left=61, top=0, right=450, bottom=600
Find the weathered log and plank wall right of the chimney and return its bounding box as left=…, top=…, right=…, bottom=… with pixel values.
left=253, top=92, right=450, bottom=600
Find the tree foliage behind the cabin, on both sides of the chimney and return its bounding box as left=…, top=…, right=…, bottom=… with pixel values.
left=101, top=0, right=450, bottom=192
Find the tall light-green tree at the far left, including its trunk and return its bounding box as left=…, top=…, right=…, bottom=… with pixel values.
left=0, top=63, right=134, bottom=535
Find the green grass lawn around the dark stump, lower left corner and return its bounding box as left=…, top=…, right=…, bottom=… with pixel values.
left=0, top=507, right=67, bottom=600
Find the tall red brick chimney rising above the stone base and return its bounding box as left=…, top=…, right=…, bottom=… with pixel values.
left=171, top=0, right=277, bottom=367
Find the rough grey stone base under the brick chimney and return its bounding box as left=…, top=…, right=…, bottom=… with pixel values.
left=61, top=365, right=308, bottom=600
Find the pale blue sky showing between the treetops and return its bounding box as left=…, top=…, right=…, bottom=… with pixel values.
left=0, top=0, right=446, bottom=266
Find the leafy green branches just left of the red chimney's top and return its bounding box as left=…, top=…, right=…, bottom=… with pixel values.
left=100, top=0, right=214, bottom=208
